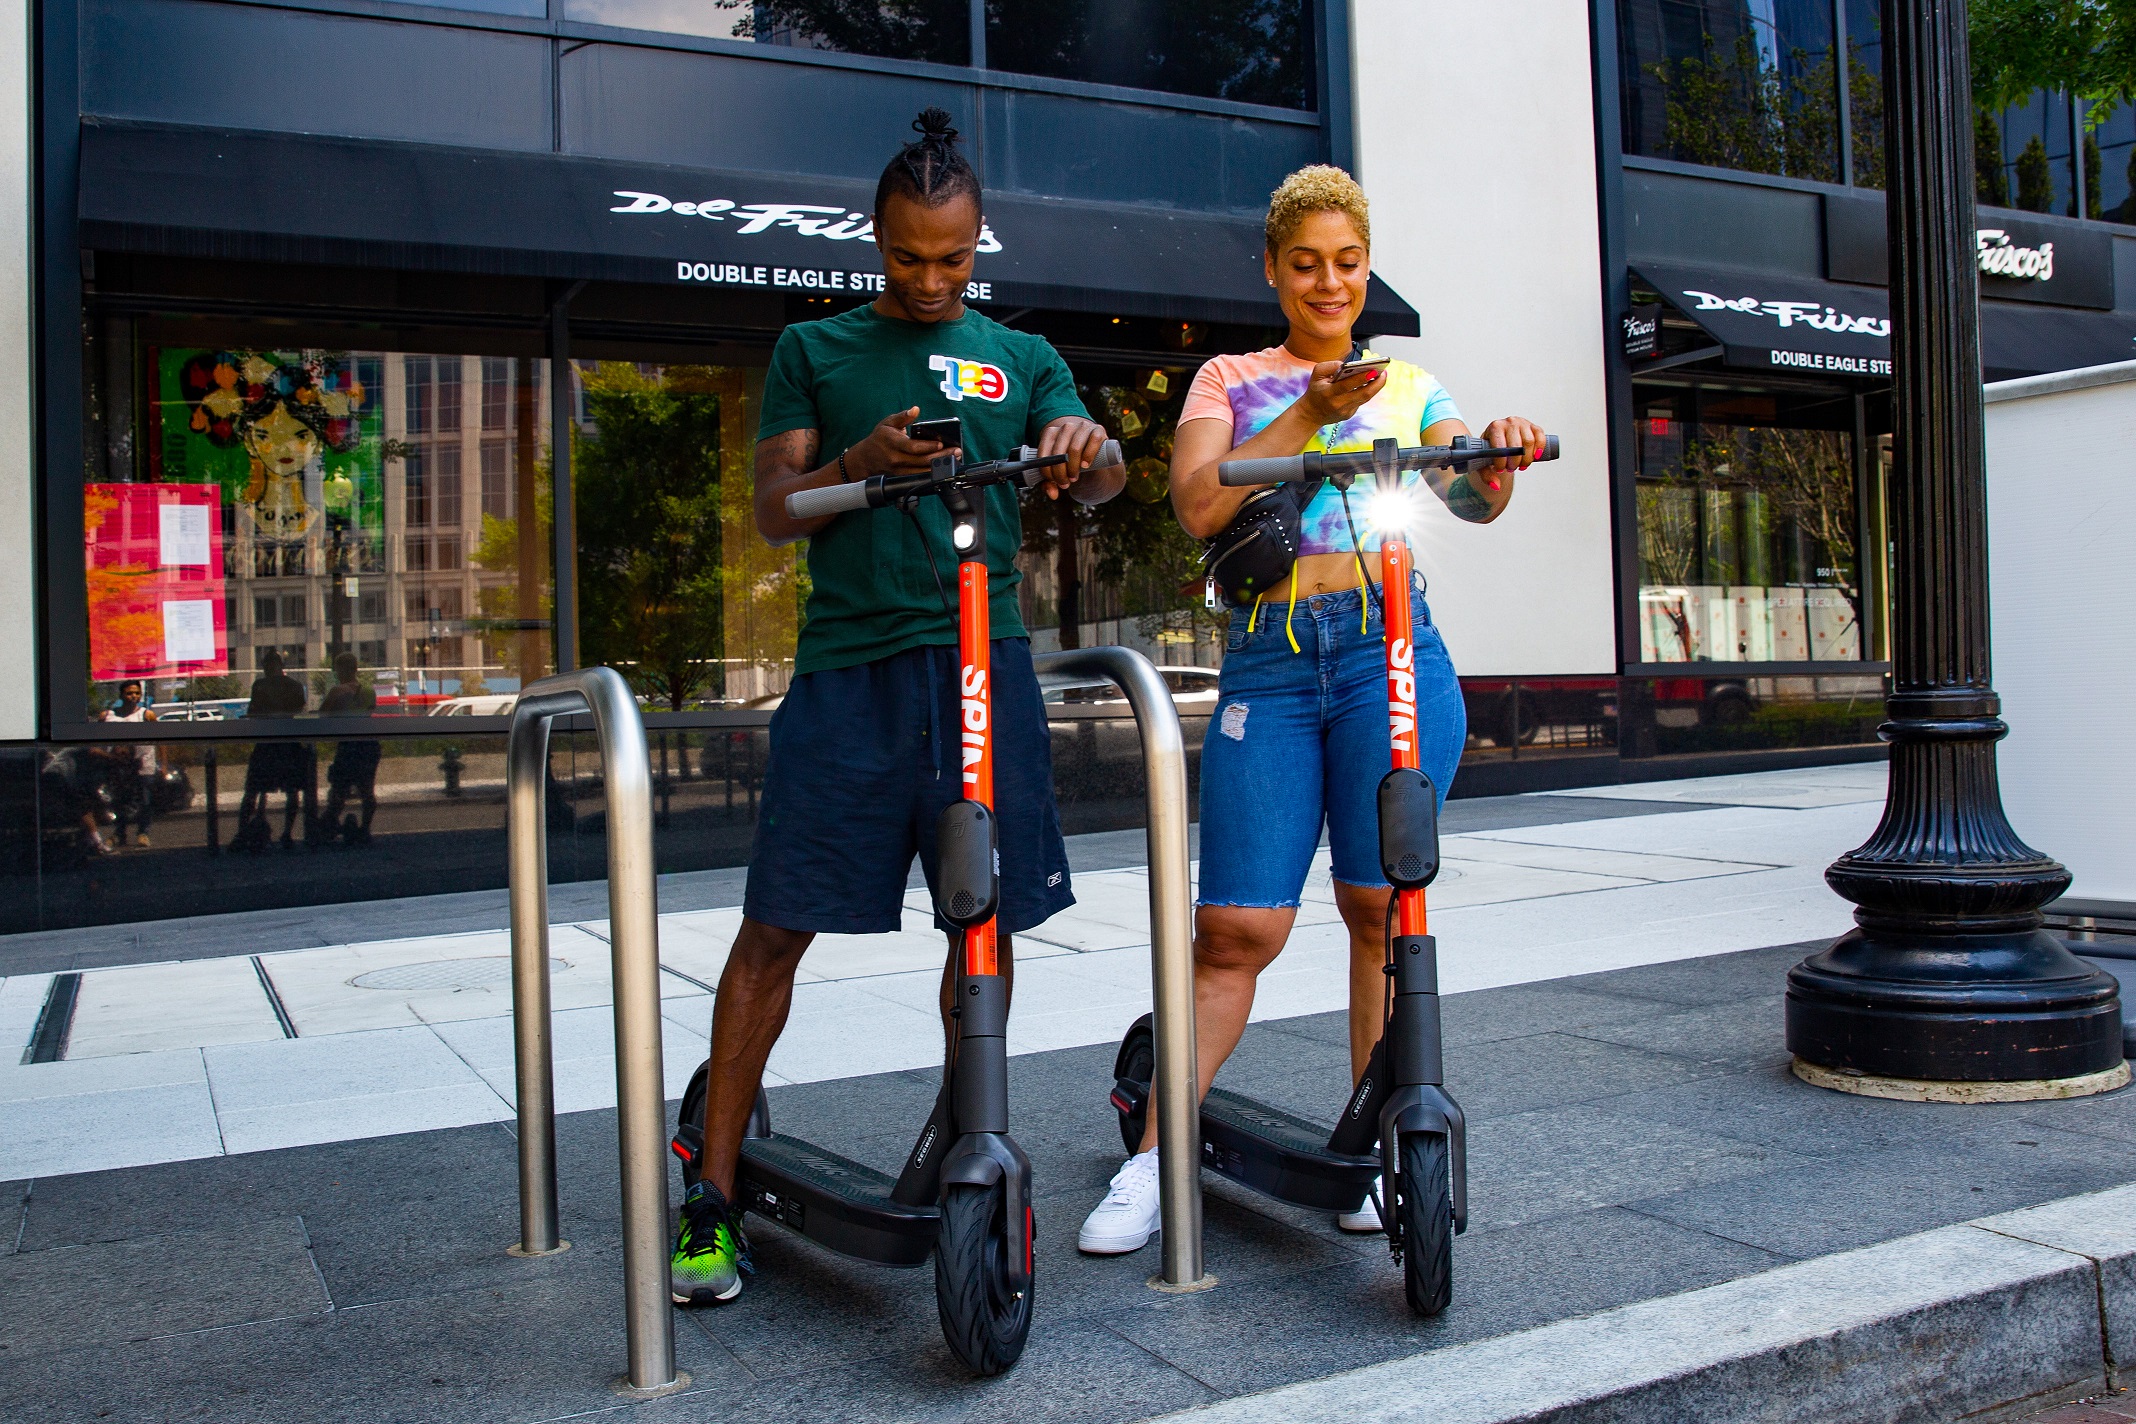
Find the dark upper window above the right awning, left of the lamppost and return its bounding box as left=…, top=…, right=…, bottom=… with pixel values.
left=1619, top=0, right=1856, bottom=181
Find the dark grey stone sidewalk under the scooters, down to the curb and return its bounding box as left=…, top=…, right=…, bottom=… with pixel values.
left=0, top=946, right=2136, bottom=1424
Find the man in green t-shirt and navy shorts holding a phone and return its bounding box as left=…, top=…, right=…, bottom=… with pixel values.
left=669, top=109, right=1104, bottom=1304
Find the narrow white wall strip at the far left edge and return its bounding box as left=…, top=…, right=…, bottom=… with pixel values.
left=0, top=0, right=38, bottom=741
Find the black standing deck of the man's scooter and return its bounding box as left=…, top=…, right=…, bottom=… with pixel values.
left=735, top=1134, right=942, bottom=1266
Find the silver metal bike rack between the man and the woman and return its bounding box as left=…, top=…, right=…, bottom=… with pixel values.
left=1032, top=647, right=1215, bottom=1292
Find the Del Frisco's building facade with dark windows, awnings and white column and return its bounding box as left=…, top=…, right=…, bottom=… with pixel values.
left=0, top=0, right=2136, bottom=931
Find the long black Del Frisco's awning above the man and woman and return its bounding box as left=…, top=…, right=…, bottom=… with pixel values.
left=81, top=124, right=1418, bottom=335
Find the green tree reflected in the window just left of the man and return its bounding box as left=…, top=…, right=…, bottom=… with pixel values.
left=572, top=361, right=724, bottom=711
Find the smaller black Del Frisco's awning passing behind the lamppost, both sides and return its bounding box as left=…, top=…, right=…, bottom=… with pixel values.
left=1632, top=263, right=2136, bottom=380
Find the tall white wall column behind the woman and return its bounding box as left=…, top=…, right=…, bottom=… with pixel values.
left=1352, top=0, right=1617, bottom=675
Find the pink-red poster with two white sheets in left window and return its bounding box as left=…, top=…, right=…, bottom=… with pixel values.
left=81, top=485, right=231, bottom=681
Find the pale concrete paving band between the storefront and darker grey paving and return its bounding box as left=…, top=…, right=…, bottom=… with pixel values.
left=0, top=764, right=1884, bottom=1178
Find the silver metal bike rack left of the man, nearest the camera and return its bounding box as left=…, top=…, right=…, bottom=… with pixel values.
left=504, top=668, right=688, bottom=1394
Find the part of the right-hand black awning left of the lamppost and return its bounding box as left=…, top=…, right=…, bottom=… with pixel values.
left=1632, top=263, right=1890, bottom=380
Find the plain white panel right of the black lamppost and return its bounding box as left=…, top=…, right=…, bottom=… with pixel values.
left=1989, top=361, right=2136, bottom=903
